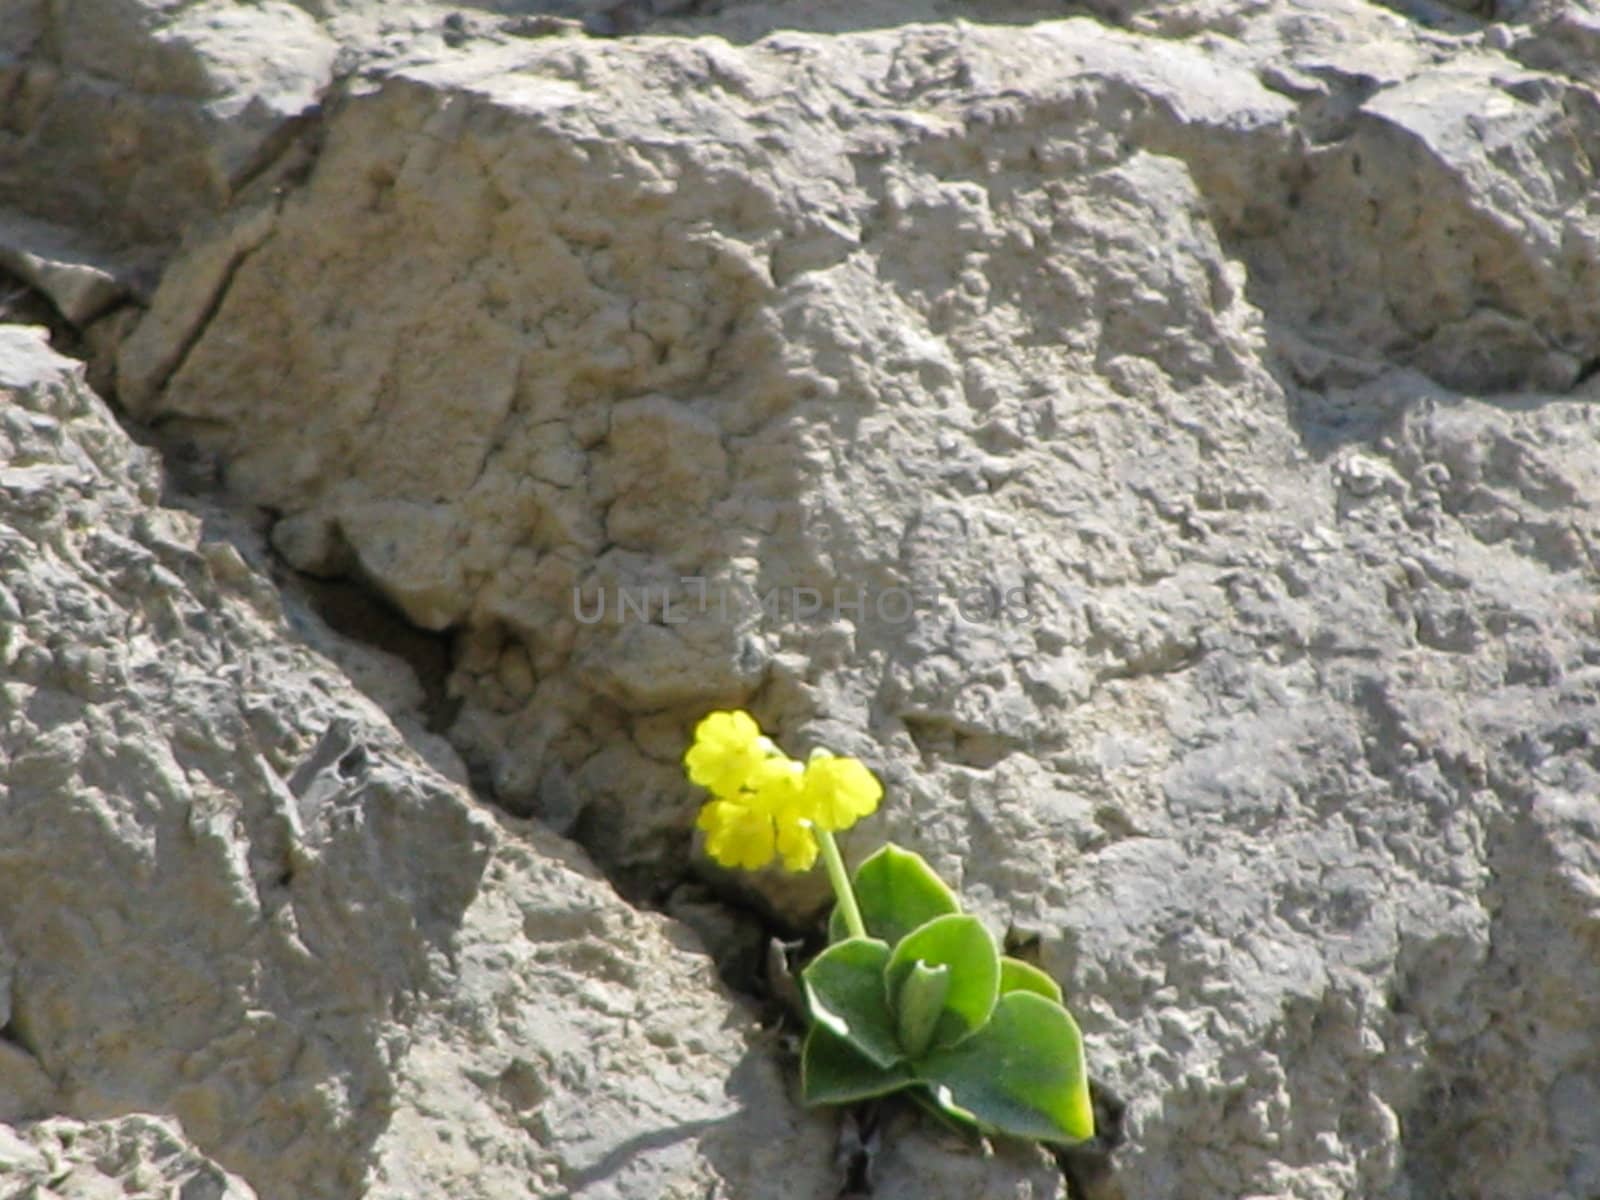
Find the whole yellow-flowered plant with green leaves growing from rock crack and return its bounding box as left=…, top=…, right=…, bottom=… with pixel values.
left=683, top=712, right=1094, bottom=1144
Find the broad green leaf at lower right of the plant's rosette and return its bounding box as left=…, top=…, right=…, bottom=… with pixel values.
left=917, top=990, right=1094, bottom=1144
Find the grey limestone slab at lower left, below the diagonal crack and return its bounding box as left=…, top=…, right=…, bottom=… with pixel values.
left=0, top=326, right=864, bottom=1200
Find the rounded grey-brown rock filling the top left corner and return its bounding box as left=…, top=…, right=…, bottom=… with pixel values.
left=0, top=0, right=338, bottom=245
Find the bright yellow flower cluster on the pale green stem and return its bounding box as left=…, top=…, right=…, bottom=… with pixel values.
left=683, top=712, right=883, bottom=870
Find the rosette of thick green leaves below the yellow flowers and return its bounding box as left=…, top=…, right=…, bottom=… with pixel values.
left=800, top=843, right=1094, bottom=1144
